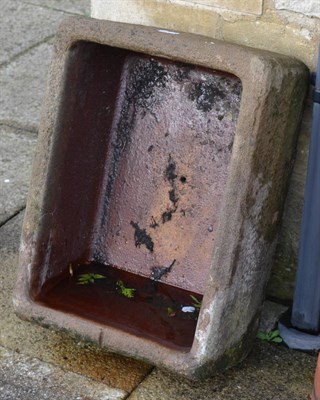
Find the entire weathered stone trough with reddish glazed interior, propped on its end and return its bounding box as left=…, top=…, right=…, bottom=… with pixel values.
left=14, top=17, right=308, bottom=379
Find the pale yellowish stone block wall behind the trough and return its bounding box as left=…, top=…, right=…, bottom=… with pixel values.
left=91, top=0, right=320, bottom=300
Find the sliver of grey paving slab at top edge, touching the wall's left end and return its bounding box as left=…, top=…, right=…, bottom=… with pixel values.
left=21, top=0, right=90, bottom=16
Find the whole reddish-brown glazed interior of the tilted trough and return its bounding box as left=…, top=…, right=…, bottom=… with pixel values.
left=33, top=42, right=242, bottom=348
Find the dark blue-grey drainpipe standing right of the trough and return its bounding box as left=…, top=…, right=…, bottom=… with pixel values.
left=279, top=49, right=320, bottom=350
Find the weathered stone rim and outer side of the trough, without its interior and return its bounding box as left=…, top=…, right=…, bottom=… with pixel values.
left=14, top=17, right=308, bottom=378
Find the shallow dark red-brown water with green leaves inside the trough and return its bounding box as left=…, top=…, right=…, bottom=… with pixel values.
left=38, top=263, right=202, bottom=350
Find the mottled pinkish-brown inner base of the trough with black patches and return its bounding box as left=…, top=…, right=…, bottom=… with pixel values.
left=93, top=45, right=241, bottom=293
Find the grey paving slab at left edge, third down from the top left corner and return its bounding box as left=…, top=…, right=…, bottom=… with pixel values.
left=0, top=126, right=36, bottom=225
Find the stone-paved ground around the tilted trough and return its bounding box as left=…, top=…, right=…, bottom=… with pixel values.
left=0, top=0, right=316, bottom=400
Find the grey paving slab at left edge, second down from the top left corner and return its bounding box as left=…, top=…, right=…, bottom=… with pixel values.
left=0, top=43, right=51, bottom=131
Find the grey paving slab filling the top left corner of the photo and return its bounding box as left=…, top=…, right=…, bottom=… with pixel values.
left=0, top=0, right=65, bottom=65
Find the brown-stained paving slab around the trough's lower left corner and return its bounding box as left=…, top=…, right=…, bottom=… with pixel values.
left=0, top=213, right=152, bottom=394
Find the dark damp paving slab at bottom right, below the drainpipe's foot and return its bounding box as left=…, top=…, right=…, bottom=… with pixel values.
left=128, top=341, right=316, bottom=400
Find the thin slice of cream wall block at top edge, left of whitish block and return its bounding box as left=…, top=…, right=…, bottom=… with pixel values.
left=182, top=0, right=263, bottom=15
